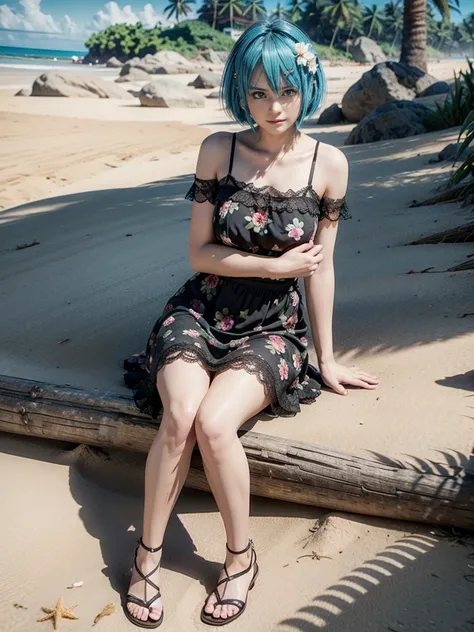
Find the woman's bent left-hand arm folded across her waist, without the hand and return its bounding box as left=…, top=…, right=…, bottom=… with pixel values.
left=189, top=132, right=280, bottom=278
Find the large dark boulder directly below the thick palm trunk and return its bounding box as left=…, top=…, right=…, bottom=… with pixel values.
left=342, top=61, right=436, bottom=123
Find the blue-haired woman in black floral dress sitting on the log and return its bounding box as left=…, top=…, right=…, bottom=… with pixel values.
left=125, top=19, right=378, bottom=628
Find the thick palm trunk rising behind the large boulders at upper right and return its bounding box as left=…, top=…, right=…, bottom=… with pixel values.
left=400, top=0, right=428, bottom=72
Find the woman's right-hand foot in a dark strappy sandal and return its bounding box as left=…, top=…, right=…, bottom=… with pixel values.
left=204, top=544, right=257, bottom=619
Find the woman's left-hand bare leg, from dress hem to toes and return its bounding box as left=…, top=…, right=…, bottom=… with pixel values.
left=127, top=360, right=210, bottom=621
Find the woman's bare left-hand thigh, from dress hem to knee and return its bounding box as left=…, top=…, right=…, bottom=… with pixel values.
left=156, top=359, right=211, bottom=433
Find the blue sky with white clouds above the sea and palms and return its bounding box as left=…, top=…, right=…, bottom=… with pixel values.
left=0, top=0, right=474, bottom=51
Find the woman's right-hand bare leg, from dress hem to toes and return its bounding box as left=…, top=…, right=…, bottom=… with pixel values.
left=195, top=369, right=269, bottom=619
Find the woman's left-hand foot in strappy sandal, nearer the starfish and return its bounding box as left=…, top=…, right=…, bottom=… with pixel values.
left=126, top=540, right=163, bottom=621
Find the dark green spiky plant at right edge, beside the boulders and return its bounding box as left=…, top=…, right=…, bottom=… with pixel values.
left=424, top=59, right=474, bottom=131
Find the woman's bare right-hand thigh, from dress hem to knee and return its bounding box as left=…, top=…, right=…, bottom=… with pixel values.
left=196, top=369, right=270, bottom=435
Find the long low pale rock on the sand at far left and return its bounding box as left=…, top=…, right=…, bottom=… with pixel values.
left=31, top=71, right=132, bottom=99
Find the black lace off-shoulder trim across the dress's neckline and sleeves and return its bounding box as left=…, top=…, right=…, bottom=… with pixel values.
left=185, top=174, right=352, bottom=221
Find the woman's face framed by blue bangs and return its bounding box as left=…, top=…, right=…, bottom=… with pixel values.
left=247, top=66, right=301, bottom=135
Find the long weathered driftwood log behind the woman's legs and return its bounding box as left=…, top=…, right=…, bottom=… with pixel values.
left=0, top=376, right=474, bottom=529
